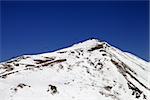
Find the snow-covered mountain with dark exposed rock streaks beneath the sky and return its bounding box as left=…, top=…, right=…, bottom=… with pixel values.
left=0, top=39, right=150, bottom=100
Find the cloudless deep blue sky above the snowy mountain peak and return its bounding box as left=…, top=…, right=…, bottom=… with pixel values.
left=0, top=1, right=149, bottom=61
